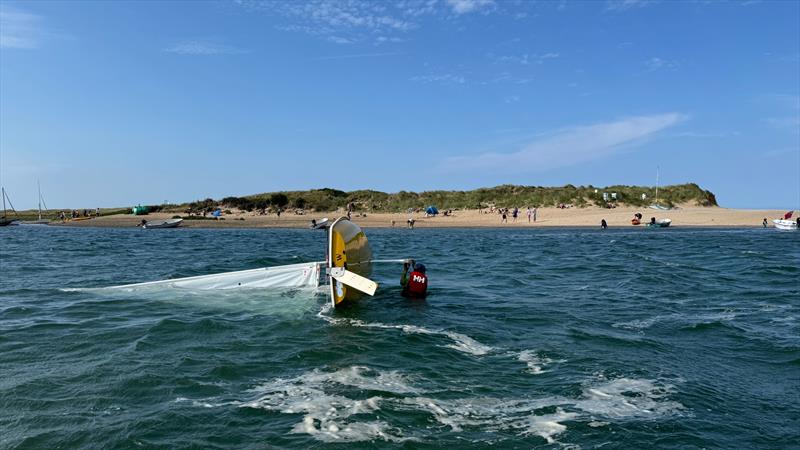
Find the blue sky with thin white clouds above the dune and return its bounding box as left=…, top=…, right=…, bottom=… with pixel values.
left=0, top=0, right=800, bottom=209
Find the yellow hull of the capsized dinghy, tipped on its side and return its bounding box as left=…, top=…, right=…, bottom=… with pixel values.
left=328, top=217, right=372, bottom=307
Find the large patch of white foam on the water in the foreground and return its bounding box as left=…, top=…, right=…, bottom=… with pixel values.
left=197, top=366, right=684, bottom=444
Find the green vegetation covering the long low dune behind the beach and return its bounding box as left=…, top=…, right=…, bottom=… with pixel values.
left=156, top=183, right=717, bottom=216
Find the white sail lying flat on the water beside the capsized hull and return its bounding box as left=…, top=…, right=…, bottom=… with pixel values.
left=102, top=262, right=320, bottom=290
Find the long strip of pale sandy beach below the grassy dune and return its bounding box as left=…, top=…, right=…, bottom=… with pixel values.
left=52, top=207, right=785, bottom=228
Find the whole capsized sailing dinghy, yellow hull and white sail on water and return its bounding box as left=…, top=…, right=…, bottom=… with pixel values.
left=97, top=217, right=378, bottom=307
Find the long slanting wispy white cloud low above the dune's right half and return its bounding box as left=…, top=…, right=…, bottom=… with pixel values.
left=444, top=113, right=686, bottom=172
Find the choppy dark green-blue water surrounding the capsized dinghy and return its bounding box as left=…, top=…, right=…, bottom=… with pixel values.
left=0, top=226, right=800, bottom=449
